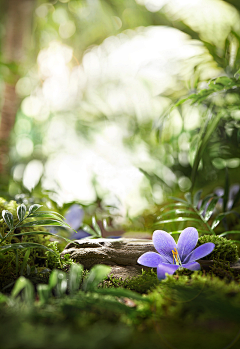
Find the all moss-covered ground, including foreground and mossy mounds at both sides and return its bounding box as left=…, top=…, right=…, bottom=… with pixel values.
left=0, top=196, right=240, bottom=349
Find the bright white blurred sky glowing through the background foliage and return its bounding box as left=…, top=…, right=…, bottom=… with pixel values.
left=15, top=0, right=240, bottom=215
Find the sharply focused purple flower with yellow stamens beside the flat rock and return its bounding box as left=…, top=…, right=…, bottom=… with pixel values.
left=138, top=227, right=215, bottom=280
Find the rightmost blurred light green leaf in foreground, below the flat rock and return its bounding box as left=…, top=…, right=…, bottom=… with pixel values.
left=82, top=264, right=111, bottom=292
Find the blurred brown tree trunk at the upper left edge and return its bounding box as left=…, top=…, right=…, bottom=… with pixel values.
left=0, top=0, right=35, bottom=175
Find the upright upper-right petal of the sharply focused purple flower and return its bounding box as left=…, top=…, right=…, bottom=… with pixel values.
left=177, top=227, right=198, bottom=262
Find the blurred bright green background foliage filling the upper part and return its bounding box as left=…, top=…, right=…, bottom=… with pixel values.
left=0, top=0, right=240, bottom=226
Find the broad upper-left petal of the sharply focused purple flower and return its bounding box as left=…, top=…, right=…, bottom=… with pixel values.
left=153, top=230, right=177, bottom=264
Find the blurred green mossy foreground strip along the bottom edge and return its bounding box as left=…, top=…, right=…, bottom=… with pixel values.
left=0, top=272, right=240, bottom=349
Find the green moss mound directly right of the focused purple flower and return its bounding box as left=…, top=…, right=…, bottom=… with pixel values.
left=197, top=235, right=239, bottom=263
